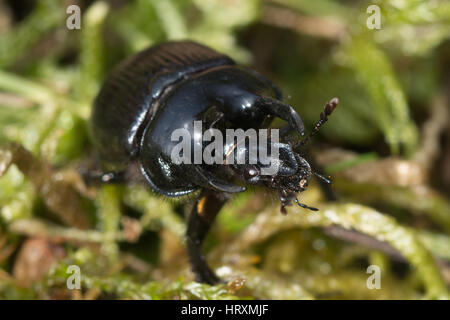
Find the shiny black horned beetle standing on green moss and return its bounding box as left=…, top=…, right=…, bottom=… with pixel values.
left=91, top=41, right=338, bottom=284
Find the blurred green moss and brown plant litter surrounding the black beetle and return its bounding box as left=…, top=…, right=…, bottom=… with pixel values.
left=0, top=0, right=450, bottom=299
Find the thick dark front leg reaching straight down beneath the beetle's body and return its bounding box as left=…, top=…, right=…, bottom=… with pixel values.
left=186, top=190, right=229, bottom=284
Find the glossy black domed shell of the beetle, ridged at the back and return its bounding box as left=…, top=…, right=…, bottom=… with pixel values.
left=91, top=41, right=281, bottom=196
